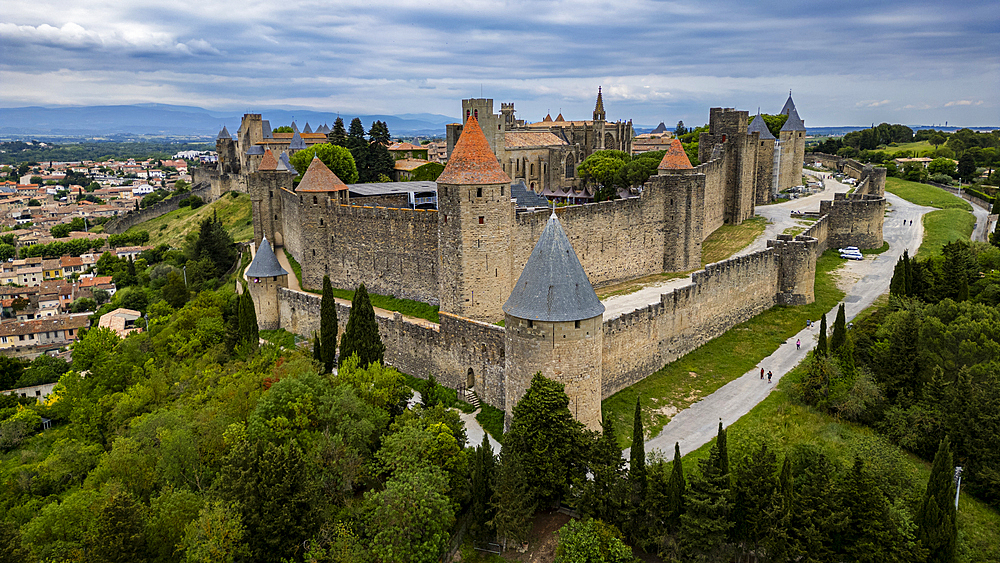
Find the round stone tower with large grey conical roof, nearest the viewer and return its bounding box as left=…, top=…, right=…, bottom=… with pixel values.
left=503, top=213, right=604, bottom=430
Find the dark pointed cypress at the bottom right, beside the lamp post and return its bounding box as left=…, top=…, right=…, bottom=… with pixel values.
left=916, top=437, right=958, bottom=563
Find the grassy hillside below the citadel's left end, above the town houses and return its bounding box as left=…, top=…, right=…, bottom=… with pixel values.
left=129, top=192, right=253, bottom=248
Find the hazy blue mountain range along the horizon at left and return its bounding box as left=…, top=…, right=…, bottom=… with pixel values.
left=0, top=104, right=458, bottom=137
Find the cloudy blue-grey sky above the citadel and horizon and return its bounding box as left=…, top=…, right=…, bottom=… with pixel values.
left=0, top=0, right=1000, bottom=126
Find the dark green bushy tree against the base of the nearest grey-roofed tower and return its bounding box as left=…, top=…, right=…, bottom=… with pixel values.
left=504, top=373, right=586, bottom=507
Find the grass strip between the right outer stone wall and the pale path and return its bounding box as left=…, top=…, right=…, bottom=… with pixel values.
left=602, top=250, right=844, bottom=447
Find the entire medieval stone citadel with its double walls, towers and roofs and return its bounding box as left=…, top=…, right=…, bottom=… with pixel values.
left=219, top=93, right=886, bottom=429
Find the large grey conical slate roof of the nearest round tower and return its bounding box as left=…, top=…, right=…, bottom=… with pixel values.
left=503, top=213, right=604, bottom=322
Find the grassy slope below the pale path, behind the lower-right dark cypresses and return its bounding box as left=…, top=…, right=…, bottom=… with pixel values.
left=680, top=364, right=1000, bottom=562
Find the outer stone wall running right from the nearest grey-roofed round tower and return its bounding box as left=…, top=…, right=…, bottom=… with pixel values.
left=601, top=249, right=780, bottom=398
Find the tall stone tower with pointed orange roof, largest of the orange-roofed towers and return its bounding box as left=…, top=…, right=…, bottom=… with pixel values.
left=437, top=115, right=514, bottom=322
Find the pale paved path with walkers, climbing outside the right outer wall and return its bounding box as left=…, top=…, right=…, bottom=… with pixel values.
left=636, top=193, right=933, bottom=457
